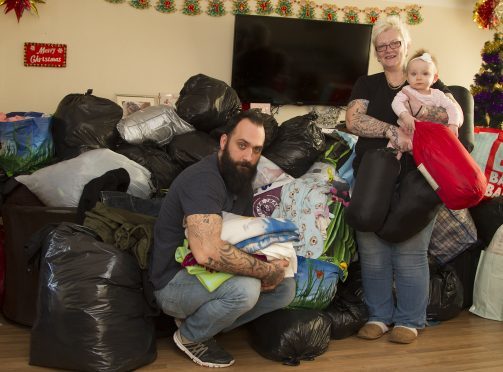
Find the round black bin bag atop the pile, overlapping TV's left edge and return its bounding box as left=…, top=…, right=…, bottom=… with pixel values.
left=176, top=74, right=241, bottom=133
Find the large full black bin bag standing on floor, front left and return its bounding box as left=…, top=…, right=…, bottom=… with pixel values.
left=30, top=223, right=156, bottom=371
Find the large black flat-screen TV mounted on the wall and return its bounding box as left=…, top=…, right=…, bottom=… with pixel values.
left=231, top=15, right=372, bottom=106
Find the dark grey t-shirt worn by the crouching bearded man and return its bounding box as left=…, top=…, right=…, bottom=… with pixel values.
left=149, top=153, right=253, bottom=290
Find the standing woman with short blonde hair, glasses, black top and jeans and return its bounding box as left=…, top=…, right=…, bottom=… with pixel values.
left=346, top=16, right=460, bottom=344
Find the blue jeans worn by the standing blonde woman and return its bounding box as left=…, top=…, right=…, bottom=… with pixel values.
left=356, top=219, right=435, bottom=329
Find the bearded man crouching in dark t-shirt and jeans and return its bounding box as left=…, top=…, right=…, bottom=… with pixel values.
left=150, top=110, right=295, bottom=367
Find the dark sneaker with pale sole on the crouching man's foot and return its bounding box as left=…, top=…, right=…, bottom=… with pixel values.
left=173, top=330, right=234, bottom=368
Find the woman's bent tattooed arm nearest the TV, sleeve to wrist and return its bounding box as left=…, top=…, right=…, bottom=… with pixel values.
left=348, top=99, right=390, bottom=138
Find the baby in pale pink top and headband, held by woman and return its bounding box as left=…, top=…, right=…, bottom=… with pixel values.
left=391, top=50, right=463, bottom=136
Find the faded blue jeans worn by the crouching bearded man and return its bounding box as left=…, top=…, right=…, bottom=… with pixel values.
left=154, top=270, right=295, bottom=342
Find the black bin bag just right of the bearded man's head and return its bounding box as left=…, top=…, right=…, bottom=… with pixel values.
left=262, top=113, right=325, bottom=178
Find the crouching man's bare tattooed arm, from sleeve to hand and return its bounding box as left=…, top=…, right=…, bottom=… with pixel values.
left=187, top=214, right=285, bottom=286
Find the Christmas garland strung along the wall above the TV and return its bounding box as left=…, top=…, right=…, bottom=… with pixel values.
left=103, top=0, right=426, bottom=25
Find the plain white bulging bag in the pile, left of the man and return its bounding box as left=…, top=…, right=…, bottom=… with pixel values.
left=16, top=149, right=152, bottom=207
